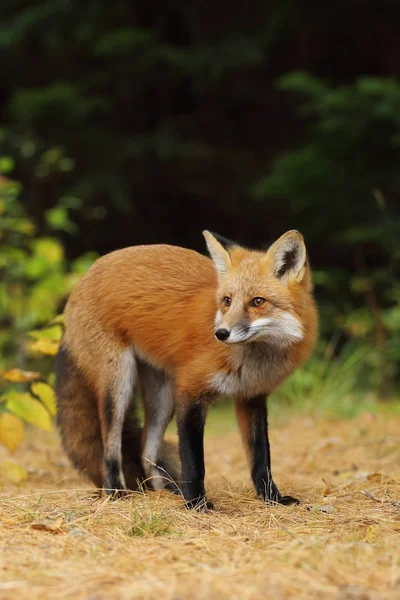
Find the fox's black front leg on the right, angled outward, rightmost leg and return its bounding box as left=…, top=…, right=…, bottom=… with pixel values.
left=236, top=396, right=298, bottom=504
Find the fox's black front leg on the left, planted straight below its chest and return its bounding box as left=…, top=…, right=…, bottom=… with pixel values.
left=177, top=402, right=213, bottom=511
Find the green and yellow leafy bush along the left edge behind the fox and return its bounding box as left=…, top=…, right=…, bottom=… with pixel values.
left=0, top=169, right=94, bottom=474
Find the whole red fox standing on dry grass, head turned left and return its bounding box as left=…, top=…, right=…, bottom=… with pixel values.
left=56, top=230, right=317, bottom=510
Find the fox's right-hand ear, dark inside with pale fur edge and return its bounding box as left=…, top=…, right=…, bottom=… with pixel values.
left=267, top=229, right=307, bottom=283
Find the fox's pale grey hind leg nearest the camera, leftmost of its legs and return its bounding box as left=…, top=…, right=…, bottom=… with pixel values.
left=100, top=348, right=137, bottom=496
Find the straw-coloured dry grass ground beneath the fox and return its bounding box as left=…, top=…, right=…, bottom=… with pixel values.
left=0, top=408, right=400, bottom=600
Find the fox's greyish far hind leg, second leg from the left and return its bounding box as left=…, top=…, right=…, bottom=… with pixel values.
left=139, top=363, right=177, bottom=491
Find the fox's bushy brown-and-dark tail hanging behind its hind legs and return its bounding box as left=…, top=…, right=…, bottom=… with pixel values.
left=56, top=344, right=179, bottom=490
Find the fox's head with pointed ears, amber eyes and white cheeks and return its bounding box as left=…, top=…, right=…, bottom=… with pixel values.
left=203, top=230, right=312, bottom=346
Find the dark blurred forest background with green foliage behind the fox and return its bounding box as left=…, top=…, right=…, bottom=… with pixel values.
left=0, top=0, right=400, bottom=432
